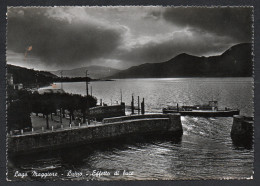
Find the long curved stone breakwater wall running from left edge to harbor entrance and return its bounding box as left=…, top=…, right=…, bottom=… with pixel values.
left=7, top=114, right=183, bottom=154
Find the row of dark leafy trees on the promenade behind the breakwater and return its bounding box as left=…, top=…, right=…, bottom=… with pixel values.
left=7, top=87, right=97, bottom=131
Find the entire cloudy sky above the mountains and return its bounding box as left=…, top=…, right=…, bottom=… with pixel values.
left=7, top=7, right=252, bottom=70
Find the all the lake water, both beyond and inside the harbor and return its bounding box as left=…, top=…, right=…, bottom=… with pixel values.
left=8, top=78, right=254, bottom=180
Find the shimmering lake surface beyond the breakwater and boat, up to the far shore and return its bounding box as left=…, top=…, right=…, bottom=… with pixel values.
left=50, top=78, right=253, bottom=115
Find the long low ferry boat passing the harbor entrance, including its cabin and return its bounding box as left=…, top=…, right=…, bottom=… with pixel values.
left=163, top=101, right=240, bottom=117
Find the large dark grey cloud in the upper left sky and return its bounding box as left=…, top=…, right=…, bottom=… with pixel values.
left=7, top=8, right=122, bottom=66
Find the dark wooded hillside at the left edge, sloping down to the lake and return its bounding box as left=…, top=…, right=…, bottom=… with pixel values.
left=7, top=64, right=57, bottom=84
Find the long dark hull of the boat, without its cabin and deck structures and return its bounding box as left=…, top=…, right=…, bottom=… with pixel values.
left=163, top=109, right=240, bottom=117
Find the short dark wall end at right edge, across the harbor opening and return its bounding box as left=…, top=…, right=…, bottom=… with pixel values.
left=231, top=115, right=254, bottom=146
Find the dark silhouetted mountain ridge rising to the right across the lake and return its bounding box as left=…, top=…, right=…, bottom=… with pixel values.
left=107, top=43, right=253, bottom=79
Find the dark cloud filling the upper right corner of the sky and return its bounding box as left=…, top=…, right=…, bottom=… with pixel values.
left=162, top=7, right=253, bottom=42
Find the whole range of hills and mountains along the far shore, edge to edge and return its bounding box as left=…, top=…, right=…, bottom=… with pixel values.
left=7, top=43, right=253, bottom=84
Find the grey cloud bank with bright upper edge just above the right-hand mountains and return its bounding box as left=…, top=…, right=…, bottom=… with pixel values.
left=117, top=29, right=237, bottom=66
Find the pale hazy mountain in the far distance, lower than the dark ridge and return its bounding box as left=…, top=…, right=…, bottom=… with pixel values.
left=51, top=65, right=120, bottom=79
